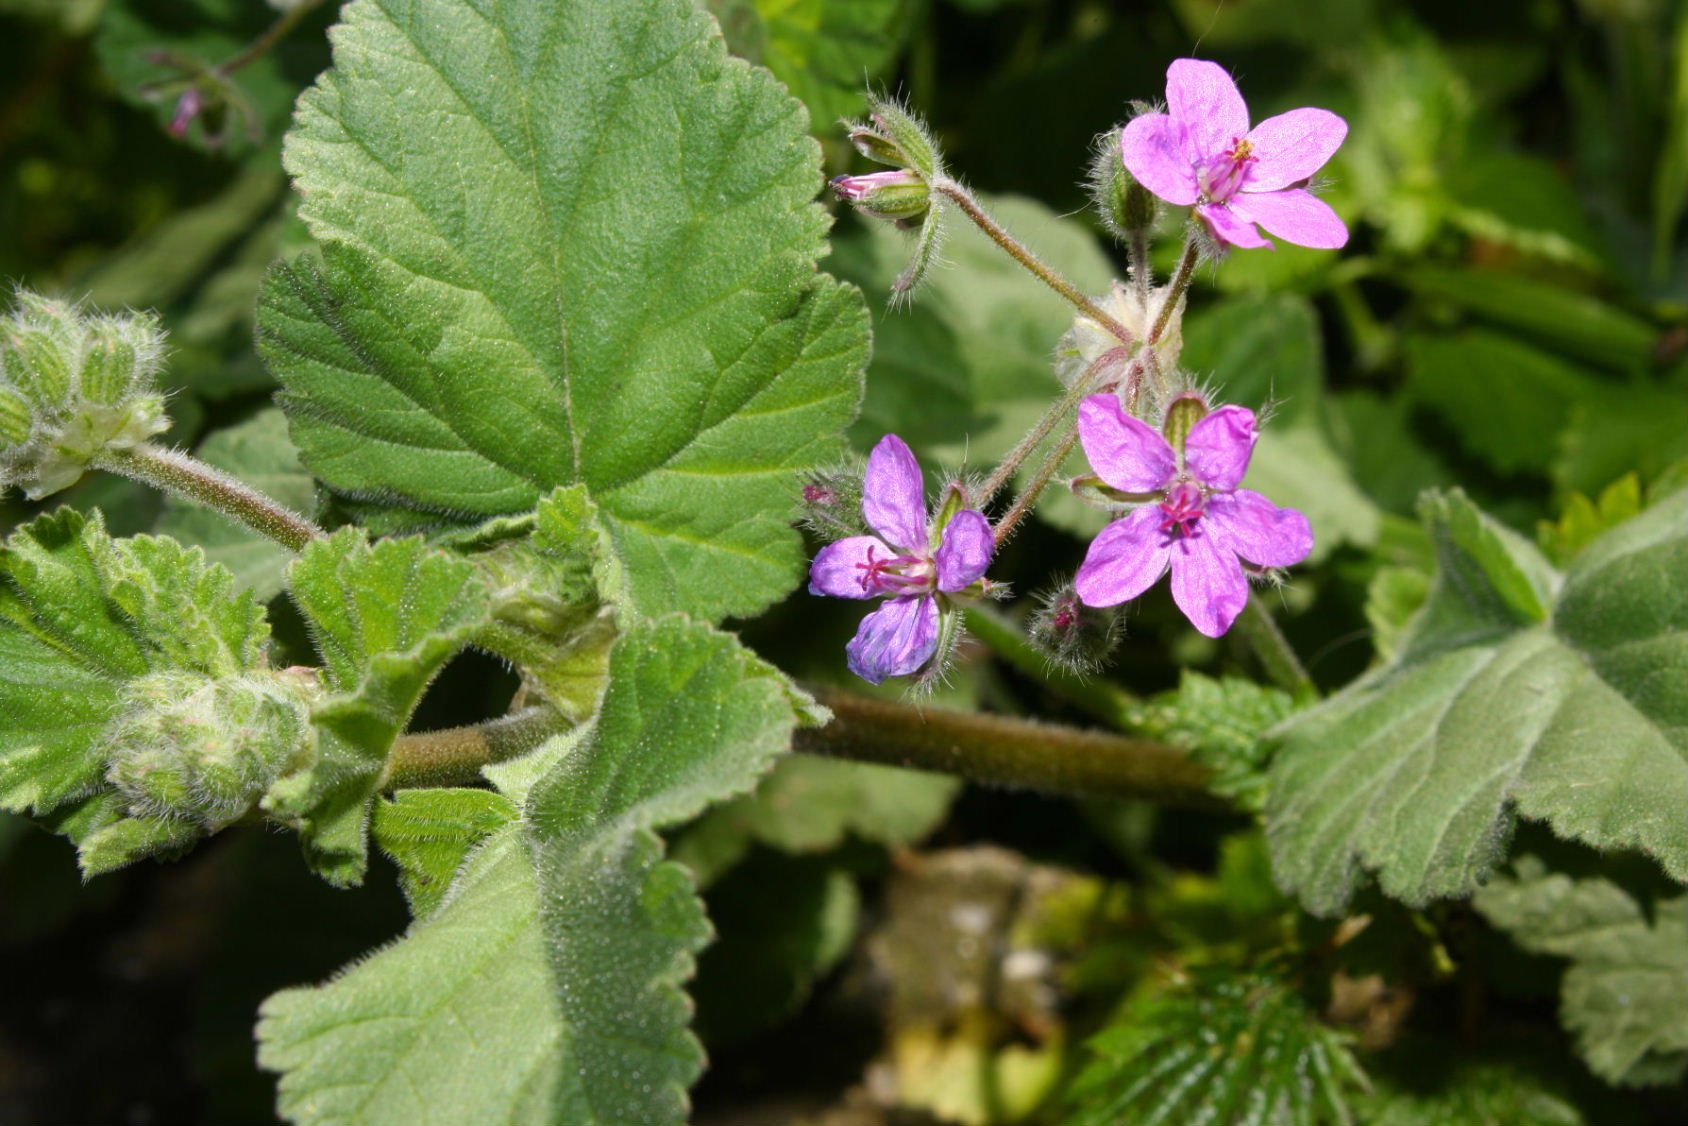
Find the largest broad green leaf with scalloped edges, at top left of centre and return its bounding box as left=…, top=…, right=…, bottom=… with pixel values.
left=260, top=0, right=868, bottom=616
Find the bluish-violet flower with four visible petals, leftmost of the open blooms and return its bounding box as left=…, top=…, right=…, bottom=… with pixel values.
left=809, top=434, right=996, bottom=684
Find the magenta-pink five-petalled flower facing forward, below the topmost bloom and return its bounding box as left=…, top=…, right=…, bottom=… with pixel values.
left=1075, top=395, right=1313, bottom=636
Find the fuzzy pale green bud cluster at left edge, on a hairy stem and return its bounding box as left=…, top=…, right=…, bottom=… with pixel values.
left=0, top=290, right=169, bottom=500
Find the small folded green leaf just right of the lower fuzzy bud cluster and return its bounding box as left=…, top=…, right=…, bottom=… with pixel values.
left=263, top=528, right=486, bottom=885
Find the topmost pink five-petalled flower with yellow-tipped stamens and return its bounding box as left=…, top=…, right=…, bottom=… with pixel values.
left=1119, top=59, right=1349, bottom=250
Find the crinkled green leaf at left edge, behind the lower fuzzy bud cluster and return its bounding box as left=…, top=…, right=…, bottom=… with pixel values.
left=0, top=508, right=268, bottom=827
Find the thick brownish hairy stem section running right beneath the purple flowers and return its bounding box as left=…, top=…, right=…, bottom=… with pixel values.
left=793, top=687, right=1225, bottom=809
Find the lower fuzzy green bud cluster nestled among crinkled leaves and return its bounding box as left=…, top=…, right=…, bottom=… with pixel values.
left=106, top=672, right=311, bottom=829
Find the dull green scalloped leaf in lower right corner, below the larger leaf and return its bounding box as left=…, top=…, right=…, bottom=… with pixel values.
left=1472, top=857, right=1688, bottom=1085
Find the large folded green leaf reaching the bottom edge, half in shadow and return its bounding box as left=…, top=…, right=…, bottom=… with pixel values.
left=258, top=618, right=810, bottom=1124
